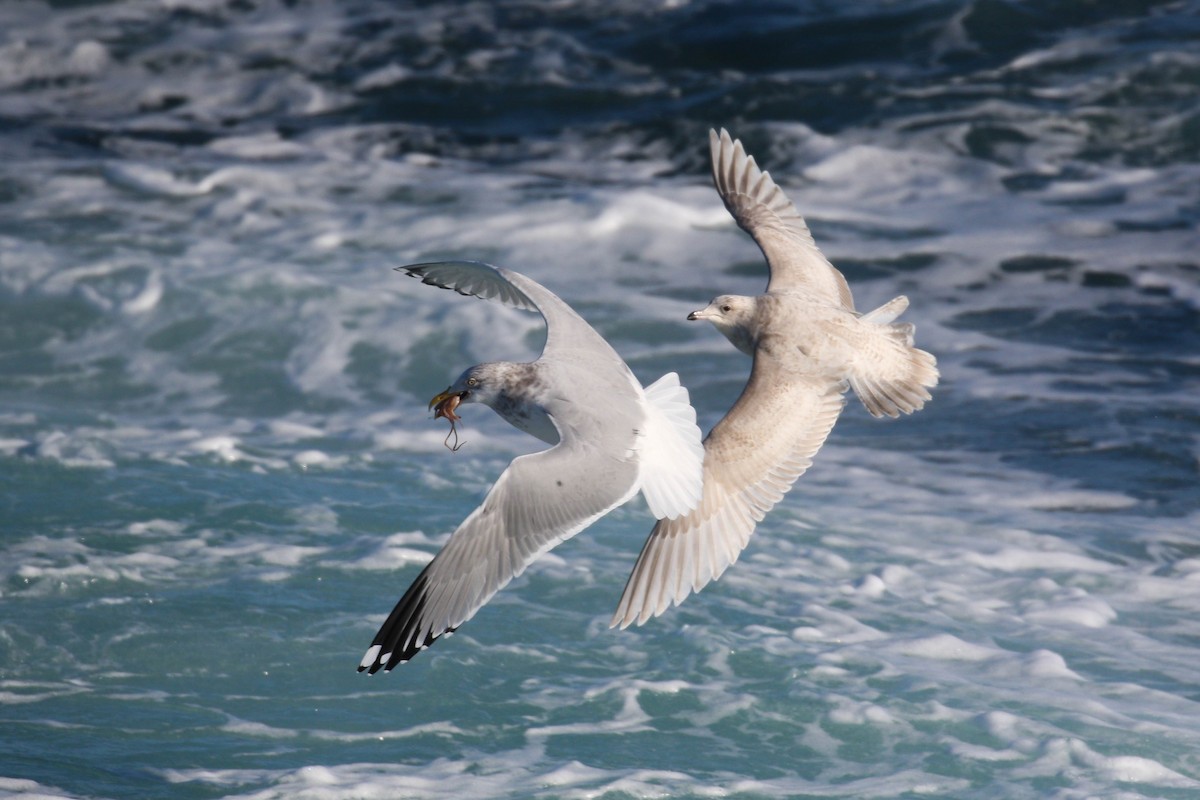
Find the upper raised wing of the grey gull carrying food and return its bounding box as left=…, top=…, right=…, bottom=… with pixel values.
left=396, top=261, right=632, bottom=362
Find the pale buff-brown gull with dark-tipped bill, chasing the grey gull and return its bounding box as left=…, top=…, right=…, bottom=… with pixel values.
left=611, top=128, right=938, bottom=628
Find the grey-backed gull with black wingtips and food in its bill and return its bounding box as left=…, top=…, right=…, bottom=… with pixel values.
left=359, top=261, right=704, bottom=674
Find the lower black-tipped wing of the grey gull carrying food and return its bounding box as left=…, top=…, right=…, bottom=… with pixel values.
left=359, top=439, right=637, bottom=673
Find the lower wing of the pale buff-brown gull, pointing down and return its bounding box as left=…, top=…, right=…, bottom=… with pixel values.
left=611, top=347, right=846, bottom=627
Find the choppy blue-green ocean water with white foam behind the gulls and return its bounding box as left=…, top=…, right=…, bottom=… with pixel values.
left=0, top=0, right=1200, bottom=800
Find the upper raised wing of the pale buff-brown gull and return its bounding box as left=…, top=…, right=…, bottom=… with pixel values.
left=708, top=128, right=854, bottom=311
